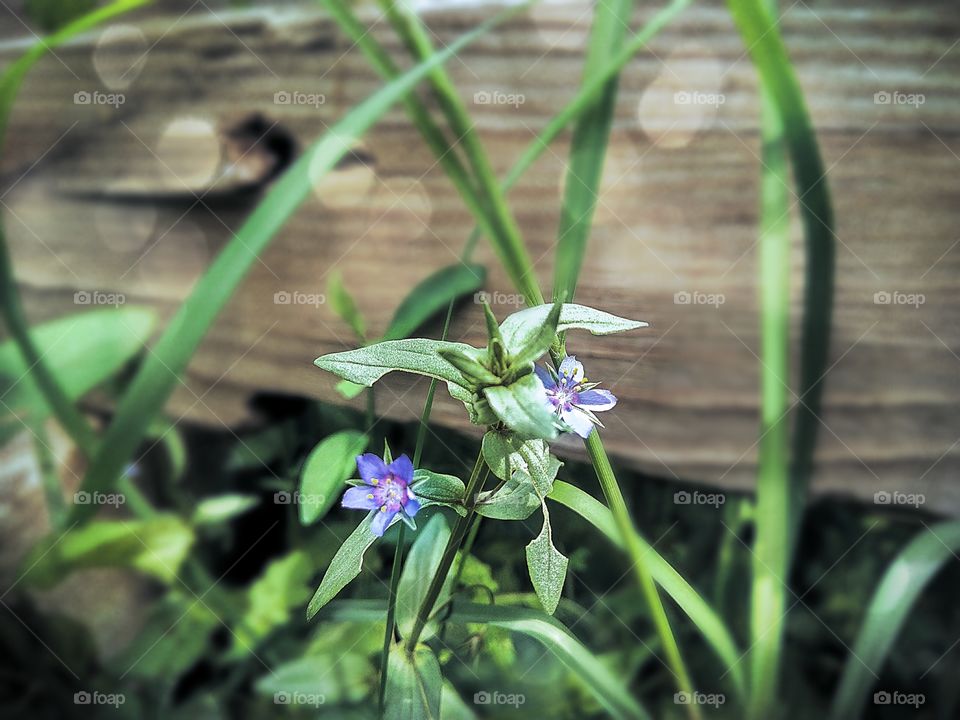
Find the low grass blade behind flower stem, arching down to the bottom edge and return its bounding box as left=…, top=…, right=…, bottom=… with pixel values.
left=327, top=600, right=650, bottom=720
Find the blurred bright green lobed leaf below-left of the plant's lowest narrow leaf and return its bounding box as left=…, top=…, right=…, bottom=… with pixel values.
left=233, top=550, right=313, bottom=656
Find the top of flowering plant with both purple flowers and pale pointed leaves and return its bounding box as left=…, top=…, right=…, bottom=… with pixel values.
left=309, top=303, right=647, bottom=620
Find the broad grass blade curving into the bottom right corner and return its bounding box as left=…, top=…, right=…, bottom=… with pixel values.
left=830, top=520, right=960, bottom=720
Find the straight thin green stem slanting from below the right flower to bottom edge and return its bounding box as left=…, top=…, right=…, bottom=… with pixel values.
left=586, top=430, right=701, bottom=719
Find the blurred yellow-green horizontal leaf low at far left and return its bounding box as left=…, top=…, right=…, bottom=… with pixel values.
left=23, top=515, right=194, bottom=588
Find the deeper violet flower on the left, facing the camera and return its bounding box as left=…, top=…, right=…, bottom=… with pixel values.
left=342, top=453, right=420, bottom=537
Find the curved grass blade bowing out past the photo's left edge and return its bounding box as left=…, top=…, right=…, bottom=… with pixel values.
left=0, top=0, right=149, bottom=457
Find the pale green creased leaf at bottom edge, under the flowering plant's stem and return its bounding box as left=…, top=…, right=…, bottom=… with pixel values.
left=384, top=645, right=443, bottom=720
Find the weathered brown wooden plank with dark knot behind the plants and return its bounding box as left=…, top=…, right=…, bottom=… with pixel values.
left=2, top=2, right=960, bottom=513
